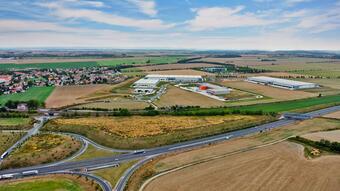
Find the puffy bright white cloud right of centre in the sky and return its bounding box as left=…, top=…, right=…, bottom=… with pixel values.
left=188, top=6, right=284, bottom=31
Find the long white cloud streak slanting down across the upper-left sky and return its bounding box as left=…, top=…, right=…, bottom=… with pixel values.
left=39, top=2, right=175, bottom=30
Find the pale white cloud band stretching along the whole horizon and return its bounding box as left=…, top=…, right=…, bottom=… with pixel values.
left=0, top=24, right=340, bottom=50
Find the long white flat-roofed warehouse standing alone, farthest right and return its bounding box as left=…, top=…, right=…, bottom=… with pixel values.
left=247, top=76, right=319, bottom=90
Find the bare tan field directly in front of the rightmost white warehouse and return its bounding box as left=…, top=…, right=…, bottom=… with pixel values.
left=221, top=80, right=318, bottom=101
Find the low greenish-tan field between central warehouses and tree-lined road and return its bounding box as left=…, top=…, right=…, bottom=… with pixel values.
left=74, top=97, right=149, bottom=110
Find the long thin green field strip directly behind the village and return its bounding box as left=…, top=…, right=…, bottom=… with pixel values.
left=0, top=62, right=98, bottom=70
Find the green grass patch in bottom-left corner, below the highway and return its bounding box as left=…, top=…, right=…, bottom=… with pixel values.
left=0, top=179, right=85, bottom=191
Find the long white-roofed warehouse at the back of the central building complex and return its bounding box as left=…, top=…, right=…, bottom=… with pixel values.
left=145, top=74, right=203, bottom=83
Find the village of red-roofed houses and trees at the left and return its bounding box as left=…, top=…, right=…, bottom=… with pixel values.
left=0, top=67, right=127, bottom=95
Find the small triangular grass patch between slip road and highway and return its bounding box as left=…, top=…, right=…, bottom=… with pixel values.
left=94, top=161, right=136, bottom=187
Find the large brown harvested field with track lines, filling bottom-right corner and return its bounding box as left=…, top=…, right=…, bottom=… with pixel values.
left=145, top=142, right=340, bottom=191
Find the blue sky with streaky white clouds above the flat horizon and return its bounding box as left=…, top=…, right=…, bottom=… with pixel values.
left=0, top=0, right=340, bottom=50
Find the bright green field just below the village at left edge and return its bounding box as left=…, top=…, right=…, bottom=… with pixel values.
left=0, top=87, right=54, bottom=105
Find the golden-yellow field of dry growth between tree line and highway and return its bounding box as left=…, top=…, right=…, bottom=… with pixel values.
left=51, top=115, right=256, bottom=137
